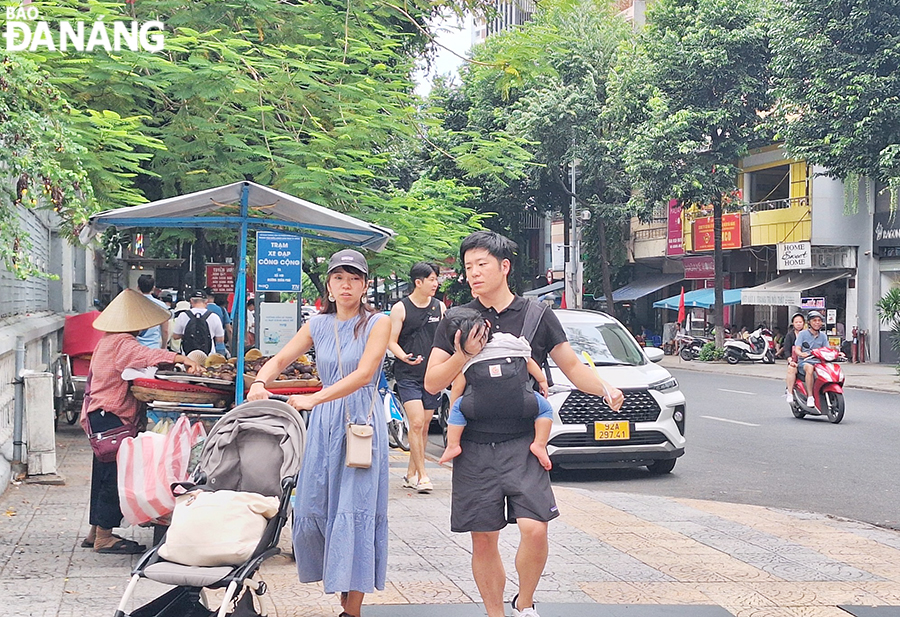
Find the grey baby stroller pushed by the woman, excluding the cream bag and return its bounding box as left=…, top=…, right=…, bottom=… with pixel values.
left=115, top=400, right=306, bottom=617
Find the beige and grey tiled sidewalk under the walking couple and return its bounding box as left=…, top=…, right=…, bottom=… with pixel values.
left=0, top=427, right=900, bottom=617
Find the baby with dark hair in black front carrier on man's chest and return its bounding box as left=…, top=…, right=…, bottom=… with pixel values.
left=440, top=307, right=553, bottom=470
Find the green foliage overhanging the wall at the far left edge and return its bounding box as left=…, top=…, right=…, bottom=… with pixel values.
left=0, top=55, right=159, bottom=279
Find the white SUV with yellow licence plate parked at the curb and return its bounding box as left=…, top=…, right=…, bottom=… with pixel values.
left=547, top=310, right=685, bottom=474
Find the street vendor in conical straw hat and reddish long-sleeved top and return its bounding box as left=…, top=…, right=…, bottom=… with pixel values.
left=81, top=289, right=203, bottom=555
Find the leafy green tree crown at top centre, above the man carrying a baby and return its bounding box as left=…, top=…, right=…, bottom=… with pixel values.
left=430, top=0, right=630, bottom=298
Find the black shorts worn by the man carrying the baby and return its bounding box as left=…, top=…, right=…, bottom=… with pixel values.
left=450, top=436, right=559, bottom=532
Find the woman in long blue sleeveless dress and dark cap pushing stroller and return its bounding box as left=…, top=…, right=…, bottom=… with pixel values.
left=247, top=249, right=391, bottom=617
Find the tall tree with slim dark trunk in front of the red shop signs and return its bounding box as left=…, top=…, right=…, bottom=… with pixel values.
left=609, top=0, right=771, bottom=346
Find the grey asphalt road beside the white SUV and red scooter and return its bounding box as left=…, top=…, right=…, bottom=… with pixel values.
left=528, top=369, right=900, bottom=529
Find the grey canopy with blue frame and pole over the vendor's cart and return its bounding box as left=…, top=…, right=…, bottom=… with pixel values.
left=80, top=181, right=394, bottom=404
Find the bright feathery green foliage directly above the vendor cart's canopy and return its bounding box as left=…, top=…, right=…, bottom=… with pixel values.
left=7, top=0, right=496, bottom=284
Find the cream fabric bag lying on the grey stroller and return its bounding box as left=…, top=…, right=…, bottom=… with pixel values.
left=159, top=490, right=278, bottom=566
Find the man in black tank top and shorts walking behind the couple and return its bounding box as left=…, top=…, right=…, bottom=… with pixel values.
left=388, top=261, right=444, bottom=493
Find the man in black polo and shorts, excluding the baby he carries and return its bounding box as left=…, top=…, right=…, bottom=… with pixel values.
left=425, top=231, right=624, bottom=617
